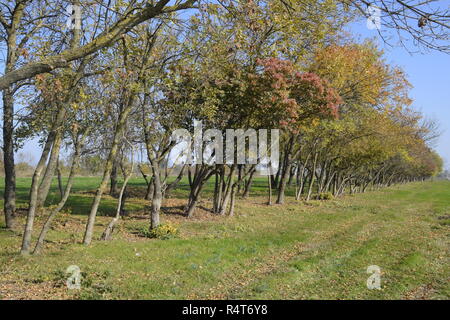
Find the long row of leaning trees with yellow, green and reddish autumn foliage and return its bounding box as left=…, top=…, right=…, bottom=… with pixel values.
left=0, top=0, right=442, bottom=254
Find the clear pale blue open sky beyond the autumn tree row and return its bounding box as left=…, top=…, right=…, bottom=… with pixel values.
left=1, top=10, right=450, bottom=169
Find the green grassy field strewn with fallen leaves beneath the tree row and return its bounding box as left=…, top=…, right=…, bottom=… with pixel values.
left=0, top=178, right=450, bottom=299
